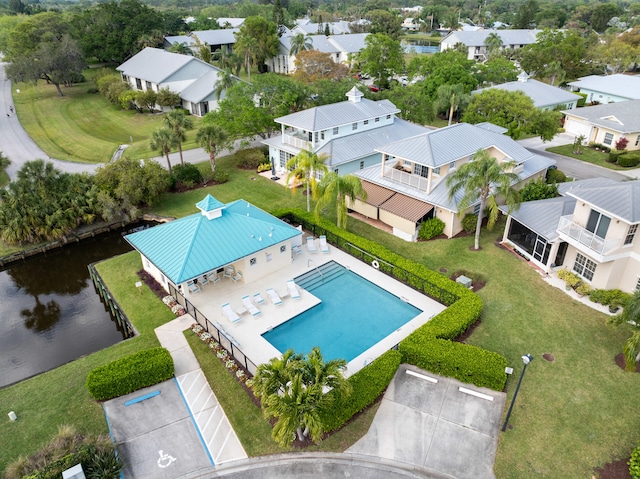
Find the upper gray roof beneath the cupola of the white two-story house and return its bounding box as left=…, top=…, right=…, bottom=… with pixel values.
left=274, top=94, right=400, bottom=131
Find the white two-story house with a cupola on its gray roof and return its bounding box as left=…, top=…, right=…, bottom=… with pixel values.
left=263, top=87, right=429, bottom=175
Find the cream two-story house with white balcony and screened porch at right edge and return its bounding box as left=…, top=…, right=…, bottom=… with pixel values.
left=503, top=178, right=640, bottom=293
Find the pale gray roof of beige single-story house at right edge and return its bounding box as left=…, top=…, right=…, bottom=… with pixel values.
left=562, top=100, right=640, bottom=133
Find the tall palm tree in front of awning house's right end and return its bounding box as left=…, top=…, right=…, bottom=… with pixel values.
left=447, top=150, right=519, bottom=250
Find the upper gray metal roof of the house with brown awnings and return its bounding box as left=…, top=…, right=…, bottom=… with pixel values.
left=377, top=123, right=532, bottom=167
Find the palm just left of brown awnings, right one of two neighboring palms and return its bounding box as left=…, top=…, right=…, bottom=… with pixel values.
left=314, top=172, right=367, bottom=228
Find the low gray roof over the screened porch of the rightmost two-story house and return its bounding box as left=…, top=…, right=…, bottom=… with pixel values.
left=500, top=196, right=576, bottom=242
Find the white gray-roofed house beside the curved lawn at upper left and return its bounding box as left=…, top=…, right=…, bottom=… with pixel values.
left=116, top=47, right=239, bottom=116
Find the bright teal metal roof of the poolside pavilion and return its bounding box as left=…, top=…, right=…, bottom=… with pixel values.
left=125, top=196, right=302, bottom=284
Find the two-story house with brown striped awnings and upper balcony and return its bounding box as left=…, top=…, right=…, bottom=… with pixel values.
left=350, top=123, right=555, bottom=241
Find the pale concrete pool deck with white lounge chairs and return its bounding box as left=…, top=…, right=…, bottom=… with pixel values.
left=182, top=235, right=445, bottom=376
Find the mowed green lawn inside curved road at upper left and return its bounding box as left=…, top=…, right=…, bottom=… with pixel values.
left=13, top=70, right=202, bottom=163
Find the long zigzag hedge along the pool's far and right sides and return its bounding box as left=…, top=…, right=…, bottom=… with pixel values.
left=274, top=210, right=507, bottom=398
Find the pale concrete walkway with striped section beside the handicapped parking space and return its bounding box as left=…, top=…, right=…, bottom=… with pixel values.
left=155, top=314, right=247, bottom=464
